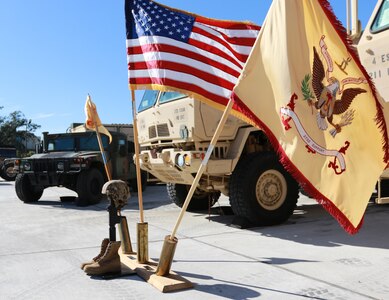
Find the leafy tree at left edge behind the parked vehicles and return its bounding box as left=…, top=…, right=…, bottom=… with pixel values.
left=0, top=106, right=41, bottom=153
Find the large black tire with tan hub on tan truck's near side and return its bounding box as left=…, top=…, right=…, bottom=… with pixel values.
left=230, top=152, right=299, bottom=226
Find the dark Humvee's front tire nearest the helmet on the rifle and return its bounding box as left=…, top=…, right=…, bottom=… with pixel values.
left=75, top=168, right=104, bottom=206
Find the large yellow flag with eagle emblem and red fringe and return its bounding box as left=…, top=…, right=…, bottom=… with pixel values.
left=233, top=0, right=388, bottom=233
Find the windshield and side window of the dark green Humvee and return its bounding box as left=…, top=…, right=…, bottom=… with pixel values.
left=47, top=134, right=109, bottom=151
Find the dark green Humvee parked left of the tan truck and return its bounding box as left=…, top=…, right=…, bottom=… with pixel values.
left=15, top=131, right=147, bottom=206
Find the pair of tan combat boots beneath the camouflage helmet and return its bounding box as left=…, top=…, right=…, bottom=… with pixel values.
left=81, top=239, right=121, bottom=275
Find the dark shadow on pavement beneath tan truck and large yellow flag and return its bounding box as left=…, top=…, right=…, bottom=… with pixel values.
left=201, top=197, right=389, bottom=249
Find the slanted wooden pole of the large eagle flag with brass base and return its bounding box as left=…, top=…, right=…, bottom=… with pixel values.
left=156, top=98, right=234, bottom=276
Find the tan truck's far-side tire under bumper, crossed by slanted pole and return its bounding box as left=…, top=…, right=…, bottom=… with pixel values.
left=166, top=183, right=220, bottom=211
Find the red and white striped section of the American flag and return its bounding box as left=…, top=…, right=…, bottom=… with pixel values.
left=127, top=17, right=260, bottom=105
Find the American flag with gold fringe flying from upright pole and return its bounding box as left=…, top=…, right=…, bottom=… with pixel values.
left=125, top=0, right=260, bottom=105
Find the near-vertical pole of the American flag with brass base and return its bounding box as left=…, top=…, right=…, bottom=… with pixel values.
left=131, top=89, right=149, bottom=263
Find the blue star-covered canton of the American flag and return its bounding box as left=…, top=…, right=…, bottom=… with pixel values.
left=132, top=0, right=195, bottom=42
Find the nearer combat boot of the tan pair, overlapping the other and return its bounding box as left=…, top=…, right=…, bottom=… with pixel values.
left=84, top=241, right=121, bottom=275
